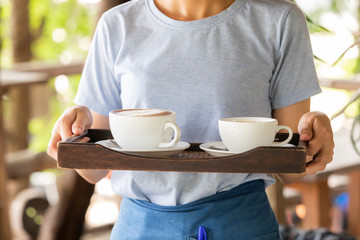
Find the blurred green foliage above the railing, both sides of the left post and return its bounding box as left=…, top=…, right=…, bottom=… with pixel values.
left=0, top=0, right=97, bottom=62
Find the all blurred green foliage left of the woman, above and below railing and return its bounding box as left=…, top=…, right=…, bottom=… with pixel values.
left=0, top=0, right=97, bottom=152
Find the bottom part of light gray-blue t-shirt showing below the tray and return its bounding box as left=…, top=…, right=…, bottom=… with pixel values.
left=111, top=171, right=274, bottom=206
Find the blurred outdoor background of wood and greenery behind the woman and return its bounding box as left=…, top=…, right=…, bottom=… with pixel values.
left=0, top=0, right=360, bottom=240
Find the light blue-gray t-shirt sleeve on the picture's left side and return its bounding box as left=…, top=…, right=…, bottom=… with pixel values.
left=74, top=17, right=122, bottom=116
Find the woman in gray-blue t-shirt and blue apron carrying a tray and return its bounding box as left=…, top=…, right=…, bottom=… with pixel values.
left=48, top=0, right=334, bottom=240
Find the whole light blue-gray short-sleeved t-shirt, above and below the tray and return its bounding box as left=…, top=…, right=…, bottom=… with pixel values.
left=75, top=0, right=321, bottom=205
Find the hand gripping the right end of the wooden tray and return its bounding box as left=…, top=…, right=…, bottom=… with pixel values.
left=298, top=112, right=335, bottom=174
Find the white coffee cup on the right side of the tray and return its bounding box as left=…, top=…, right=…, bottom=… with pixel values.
left=218, top=117, right=293, bottom=153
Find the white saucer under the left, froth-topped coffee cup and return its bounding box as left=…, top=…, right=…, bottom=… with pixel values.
left=96, top=139, right=190, bottom=157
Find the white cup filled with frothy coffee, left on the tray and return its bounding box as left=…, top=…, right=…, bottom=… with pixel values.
left=109, top=109, right=181, bottom=150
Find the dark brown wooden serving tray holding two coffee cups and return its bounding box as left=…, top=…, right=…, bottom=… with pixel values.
left=58, top=129, right=306, bottom=173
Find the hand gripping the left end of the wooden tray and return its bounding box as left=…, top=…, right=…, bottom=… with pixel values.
left=47, top=105, right=93, bottom=160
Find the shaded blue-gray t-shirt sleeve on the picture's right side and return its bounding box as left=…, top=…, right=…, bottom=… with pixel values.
left=269, top=5, right=321, bottom=109
